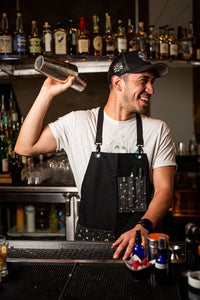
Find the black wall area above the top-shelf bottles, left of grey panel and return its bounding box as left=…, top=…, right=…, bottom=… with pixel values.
left=0, top=0, right=148, bottom=34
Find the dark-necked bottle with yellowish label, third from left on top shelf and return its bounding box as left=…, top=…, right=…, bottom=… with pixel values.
left=28, top=20, right=42, bottom=56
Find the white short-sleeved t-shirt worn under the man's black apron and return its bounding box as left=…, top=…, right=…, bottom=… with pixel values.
left=49, top=108, right=176, bottom=194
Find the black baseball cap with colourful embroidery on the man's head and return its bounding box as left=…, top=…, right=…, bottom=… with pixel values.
left=108, top=50, right=169, bottom=84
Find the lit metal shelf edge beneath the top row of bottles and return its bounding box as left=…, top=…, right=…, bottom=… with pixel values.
left=0, top=56, right=200, bottom=78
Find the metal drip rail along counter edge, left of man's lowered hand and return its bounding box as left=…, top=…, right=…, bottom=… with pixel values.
left=7, top=240, right=118, bottom=263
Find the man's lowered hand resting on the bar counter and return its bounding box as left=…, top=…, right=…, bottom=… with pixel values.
left=112, top=224, right=149, bottom=259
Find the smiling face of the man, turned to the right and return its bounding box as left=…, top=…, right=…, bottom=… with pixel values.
left=121, top=71, right=155, bottom=113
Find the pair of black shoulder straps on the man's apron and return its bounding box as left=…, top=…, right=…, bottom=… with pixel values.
left=95, top=107, right=144, bottom=157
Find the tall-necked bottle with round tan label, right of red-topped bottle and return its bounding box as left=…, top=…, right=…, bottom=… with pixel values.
left=90, top=14, right=103, bottom=56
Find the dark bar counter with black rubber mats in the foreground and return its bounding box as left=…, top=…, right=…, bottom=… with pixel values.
left=0, top=240, right=197, bottom=300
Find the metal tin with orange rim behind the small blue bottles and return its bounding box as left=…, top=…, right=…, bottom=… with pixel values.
left=147, top=233, right=169, bottom=261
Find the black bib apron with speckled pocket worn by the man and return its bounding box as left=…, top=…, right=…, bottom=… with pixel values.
left=75, top=108, right=152, bottom=241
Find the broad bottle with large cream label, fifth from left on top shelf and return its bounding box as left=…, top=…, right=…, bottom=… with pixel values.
left=53, top=22, right=67, bottom=55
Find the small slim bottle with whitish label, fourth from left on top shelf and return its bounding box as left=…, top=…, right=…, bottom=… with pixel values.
left=42, top=22, right=53, bottom=56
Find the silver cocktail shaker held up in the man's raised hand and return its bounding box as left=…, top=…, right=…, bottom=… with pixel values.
left=34, top=55, right=87, bottom=92
